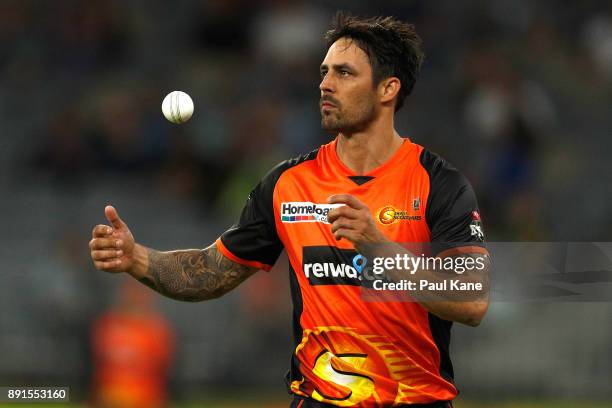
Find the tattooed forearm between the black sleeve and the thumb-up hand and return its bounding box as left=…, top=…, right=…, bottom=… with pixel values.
left=139, top=245, right=257, bottom=302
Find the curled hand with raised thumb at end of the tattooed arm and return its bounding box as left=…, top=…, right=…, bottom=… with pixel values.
left=89, top=205, right=134, bottom=273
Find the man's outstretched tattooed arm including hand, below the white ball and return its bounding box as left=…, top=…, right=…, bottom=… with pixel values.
left=89, top=206, right=258, bottom=302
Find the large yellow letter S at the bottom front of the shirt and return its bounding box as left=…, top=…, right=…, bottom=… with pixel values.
left=312, top=350, right=375, bottom=407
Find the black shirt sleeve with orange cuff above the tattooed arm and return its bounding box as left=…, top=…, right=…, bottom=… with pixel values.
left=216, top=162, right=286, bottom=271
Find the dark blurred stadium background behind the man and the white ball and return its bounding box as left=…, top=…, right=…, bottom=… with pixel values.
left=0, top=0, right=612, bottom=408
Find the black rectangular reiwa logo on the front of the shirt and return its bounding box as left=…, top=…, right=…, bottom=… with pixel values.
left=302, top=246, right=368, bottom=286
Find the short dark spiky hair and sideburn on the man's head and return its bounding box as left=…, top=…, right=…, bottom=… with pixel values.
left=324, top=12, right=425, bottom=112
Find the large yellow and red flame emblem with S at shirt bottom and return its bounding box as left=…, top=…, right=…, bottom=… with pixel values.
left=291, top=327, right=430, bottom=407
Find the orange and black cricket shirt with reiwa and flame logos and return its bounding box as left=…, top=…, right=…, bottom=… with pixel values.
left=217, top=139, right=482, bottom=407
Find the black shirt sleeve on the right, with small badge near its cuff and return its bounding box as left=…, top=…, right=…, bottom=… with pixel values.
left=426, top=150, right=485, bottom=254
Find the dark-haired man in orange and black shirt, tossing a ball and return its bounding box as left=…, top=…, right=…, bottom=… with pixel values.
left=90, top=15, right=488, bottom=407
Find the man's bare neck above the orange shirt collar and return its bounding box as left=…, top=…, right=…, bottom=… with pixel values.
left=336, top=118, right=403, bottom=175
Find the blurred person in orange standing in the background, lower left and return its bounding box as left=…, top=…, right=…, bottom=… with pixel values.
left=91, top=280, right=174, bottom=408
